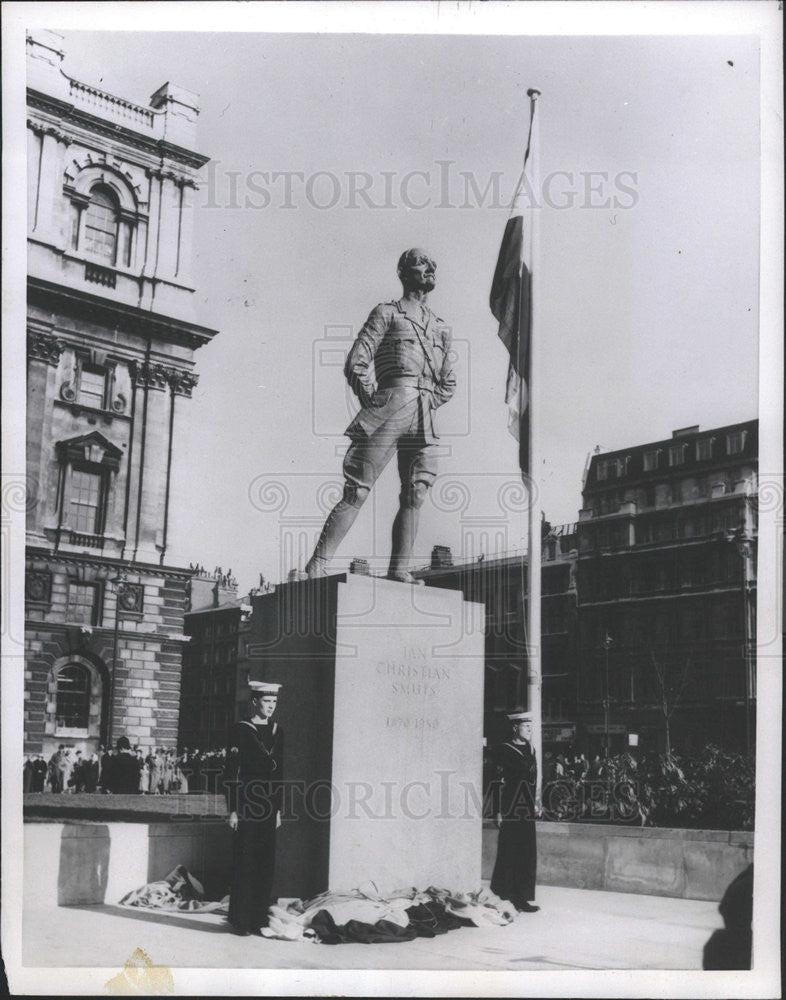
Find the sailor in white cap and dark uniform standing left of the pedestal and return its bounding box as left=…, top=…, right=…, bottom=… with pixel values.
left=224, top=681, right=284, bottom=936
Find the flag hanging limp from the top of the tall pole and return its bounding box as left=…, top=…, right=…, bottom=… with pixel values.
left=489, top=90, right=539, bottom=475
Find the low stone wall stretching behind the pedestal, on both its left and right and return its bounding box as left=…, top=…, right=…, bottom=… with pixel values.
left=24, top=816, right=753, bottom=908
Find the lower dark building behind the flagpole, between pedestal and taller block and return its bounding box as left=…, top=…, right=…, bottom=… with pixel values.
left=415, top=524, right=578, bottom=751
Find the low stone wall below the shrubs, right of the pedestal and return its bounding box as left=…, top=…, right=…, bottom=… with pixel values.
left=482, top=821, right=753, bottom=900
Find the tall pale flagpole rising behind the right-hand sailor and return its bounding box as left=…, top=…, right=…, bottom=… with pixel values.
left=527, top=88, right=543, bottom=807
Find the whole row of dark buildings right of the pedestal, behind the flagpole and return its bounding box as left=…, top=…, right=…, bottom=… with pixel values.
left=416, top=420, right=758, bottom=754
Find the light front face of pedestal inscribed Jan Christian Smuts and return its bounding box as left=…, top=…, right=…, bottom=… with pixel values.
left=330, top=578, right=483, bottom=889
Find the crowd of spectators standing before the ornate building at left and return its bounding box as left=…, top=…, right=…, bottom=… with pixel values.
left=23, top=736, right=233, bottom=795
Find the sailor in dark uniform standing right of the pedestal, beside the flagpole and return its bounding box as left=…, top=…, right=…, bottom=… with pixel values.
left=491, top=712, right=539, bottom=913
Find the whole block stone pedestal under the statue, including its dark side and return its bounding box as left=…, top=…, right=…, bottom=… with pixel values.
left=248, top=574, right=484, bottom=897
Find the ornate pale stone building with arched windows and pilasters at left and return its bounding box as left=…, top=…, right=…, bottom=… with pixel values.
left=25, top=30, right=216, bottom=754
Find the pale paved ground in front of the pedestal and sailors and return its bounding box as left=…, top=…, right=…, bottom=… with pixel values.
left=22, top=886, right=722, bottom=971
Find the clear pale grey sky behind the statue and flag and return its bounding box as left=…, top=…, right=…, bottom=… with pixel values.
left=53, top=25, right=760, bottom=592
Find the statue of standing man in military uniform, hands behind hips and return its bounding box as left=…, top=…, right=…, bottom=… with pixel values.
left=306, top=248, right=456, bottom=583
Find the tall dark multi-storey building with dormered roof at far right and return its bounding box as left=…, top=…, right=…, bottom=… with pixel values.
left=577, top=420, right=758, bottom=750
